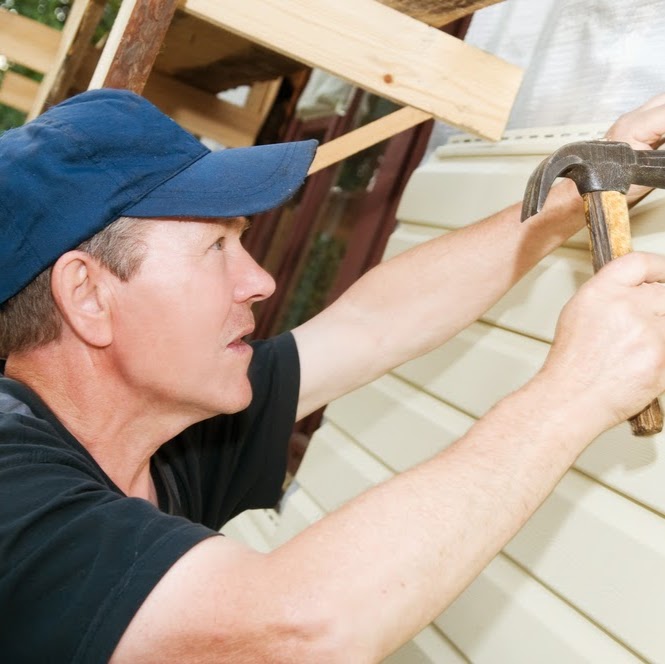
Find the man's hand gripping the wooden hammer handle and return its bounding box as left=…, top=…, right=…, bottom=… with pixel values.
left=541, top=253, right=665, bottom=428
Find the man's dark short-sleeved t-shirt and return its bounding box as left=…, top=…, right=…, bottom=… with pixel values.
left=0, top=334, right=300, bottom=664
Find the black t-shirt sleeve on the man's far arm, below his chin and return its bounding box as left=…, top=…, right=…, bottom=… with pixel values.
left=158, top=332, right=300, bottom=530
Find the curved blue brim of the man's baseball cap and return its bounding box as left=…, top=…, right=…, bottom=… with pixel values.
left=122, top=140, right=317, bottom=218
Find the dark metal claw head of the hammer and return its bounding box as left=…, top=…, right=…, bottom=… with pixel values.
left=522, top=141, right=665, bottom=221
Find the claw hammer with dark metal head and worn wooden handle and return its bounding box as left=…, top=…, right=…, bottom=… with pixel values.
left=522, top=140, right=665, bottom=436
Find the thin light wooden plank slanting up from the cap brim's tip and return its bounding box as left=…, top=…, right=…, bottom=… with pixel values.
left=308, top=106, right=432, bottom=175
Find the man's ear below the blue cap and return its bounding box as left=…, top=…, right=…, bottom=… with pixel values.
left=51, top=250, right=113, bottom=348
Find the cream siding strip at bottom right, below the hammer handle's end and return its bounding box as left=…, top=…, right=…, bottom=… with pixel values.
left=505, top=471, right=665, bottom=662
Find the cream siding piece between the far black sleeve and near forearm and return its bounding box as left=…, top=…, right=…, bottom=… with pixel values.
left=296, top=423, right=393, bottom=512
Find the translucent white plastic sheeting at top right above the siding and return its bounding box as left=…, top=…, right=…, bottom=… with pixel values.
left=428, top=0, right=665, bottom=155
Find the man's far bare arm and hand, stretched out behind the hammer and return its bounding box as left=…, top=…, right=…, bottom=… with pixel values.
left=294, top=95, right=665, bottom=418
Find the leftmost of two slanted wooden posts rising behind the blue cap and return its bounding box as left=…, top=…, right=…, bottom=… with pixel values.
left=27, top=0, right=106, bottom=120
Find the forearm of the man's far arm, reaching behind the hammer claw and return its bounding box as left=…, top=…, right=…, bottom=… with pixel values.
left=348, top=181, right=584, bottom=364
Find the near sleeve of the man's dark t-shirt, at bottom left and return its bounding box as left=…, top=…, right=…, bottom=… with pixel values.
left=0, top=430, right=217, bottom=664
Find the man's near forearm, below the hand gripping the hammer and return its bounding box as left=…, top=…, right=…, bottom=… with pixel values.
left=271, top=376, right=607, bottom=661
